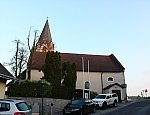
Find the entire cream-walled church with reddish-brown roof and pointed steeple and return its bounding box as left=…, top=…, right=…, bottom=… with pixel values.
left=26, top=20, right=127, bottom=101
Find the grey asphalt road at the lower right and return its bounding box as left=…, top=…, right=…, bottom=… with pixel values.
left=90, top=100, right=150, bottom=115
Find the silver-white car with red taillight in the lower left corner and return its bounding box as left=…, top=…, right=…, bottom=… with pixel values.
left=0, top=99, right=32, bottom=115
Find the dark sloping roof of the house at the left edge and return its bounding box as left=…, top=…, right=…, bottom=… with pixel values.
left=0, top=63, right=14, bottom=80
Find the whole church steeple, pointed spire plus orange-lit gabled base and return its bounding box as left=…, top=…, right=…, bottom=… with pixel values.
left=36, top=19, right=54, bottom=52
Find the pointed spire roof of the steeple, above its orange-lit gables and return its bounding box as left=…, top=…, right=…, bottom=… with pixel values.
left=38, top=19, right=52, bottom=44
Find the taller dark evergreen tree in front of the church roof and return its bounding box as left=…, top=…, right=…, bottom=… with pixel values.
left=42, top=51, right=61, bottom=86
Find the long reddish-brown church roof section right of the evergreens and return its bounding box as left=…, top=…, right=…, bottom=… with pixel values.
left=61, top=53, right=125, bottom=72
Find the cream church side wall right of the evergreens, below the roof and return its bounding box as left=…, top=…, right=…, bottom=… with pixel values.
left=76, top=72, right=125, bottom=93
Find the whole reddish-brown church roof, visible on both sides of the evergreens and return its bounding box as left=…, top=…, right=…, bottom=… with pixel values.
left=31, top=52, right=125, bottom=72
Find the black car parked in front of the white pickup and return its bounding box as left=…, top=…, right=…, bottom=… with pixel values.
left=63, top=99, right=95, bottom=115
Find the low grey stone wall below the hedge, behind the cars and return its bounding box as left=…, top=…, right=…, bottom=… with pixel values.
left=13, top=97, right=70, bottom=115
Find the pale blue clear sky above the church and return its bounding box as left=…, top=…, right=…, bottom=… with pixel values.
left=0, top=0, right=150, bottom=96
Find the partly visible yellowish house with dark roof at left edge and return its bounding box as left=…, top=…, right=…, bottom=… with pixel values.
left=0, top=63, right=14, bottom=99
